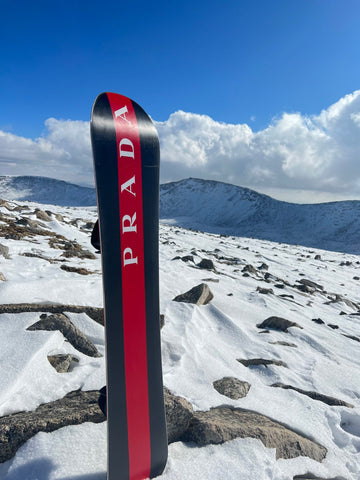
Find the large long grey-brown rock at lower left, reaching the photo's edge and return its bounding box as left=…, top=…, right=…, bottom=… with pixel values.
left=0, top=390, right=105, bottom=463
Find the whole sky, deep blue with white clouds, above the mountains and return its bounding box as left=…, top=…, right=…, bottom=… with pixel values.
left=0, top=0, right=360, bottom=203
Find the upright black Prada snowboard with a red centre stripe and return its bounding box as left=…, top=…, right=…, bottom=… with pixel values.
left=90, top=93, right=167, bottom=480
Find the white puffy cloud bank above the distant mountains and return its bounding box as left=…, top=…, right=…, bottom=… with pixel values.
left=0, top=90, right=360, bottom=201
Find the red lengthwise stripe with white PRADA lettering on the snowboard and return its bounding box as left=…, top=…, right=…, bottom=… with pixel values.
left=107, top=93, right=151, bottom=480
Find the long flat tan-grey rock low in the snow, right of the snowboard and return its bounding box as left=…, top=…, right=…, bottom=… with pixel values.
left=182, top=406, right=327, bottom=462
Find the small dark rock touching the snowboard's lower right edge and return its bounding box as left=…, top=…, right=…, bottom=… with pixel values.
left=164, top=387, right=194, bottom=443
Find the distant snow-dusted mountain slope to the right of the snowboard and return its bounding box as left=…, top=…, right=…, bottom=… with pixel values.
left=160, top=179, right=360, bottom=254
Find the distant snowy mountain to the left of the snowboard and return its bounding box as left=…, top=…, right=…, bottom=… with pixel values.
left=0, top=176, right=96, bottom=207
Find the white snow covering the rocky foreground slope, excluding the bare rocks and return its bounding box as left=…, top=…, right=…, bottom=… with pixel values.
left=0, top=197, right=360, bottom=480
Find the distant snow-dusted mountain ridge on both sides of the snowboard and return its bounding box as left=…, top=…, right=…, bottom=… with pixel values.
left=0, top=176, right=360, bottom=255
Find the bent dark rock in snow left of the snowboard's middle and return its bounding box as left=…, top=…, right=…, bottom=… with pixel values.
left=27, top=313, right=101, bottom=357
